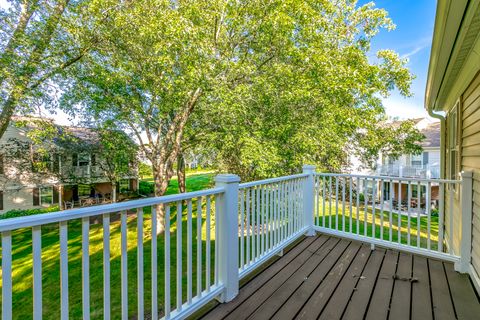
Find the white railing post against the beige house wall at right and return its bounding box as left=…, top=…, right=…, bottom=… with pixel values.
left=458, top=171, right=473, bottom=273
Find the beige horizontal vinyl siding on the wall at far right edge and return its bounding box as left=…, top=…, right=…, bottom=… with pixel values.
left=460, top=73, right=480, bottom=273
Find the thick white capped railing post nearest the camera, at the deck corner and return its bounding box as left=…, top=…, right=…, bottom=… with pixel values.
left=215, top=174, right=240, bottom=302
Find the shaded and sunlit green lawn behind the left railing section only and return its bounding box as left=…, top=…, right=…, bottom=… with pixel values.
left=1, top=174, right=215, bottom=319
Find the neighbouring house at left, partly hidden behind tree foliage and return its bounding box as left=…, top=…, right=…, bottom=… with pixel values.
left=0, top=117, right=138, bottom=214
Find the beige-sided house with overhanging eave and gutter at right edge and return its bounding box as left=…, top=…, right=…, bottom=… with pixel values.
left=425, top=0, right=480, bottom=289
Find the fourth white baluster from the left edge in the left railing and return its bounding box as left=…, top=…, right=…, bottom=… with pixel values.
left=82, top=217, right=90, bottom=319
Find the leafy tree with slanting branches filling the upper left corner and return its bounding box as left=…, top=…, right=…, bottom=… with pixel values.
left=0, top=0, right=115, bottom=138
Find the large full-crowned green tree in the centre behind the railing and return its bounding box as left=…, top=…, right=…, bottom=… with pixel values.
left=59, top=0, right=420, bottom=230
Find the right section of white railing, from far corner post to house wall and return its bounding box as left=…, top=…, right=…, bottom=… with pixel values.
left=315, top=173, right=461, bottom=262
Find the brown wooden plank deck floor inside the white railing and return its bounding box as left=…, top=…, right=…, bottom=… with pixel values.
left=204, top=235, right=480, bottom=320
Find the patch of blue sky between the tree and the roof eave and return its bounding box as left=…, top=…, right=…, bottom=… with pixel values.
left=359, top=0, right=436, bottom=118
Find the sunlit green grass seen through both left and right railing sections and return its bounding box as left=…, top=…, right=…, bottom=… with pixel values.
left=0, top=174, right=438, bottom=319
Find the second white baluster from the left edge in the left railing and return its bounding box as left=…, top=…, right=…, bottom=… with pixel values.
left=32, top=226, right=42, bottom=319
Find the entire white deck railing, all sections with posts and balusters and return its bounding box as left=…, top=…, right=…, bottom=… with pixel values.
left=0, top=166, right=471, bottom=319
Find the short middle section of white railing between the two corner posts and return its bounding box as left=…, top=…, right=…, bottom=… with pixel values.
left=239, top=174, right=309, bottom=278
